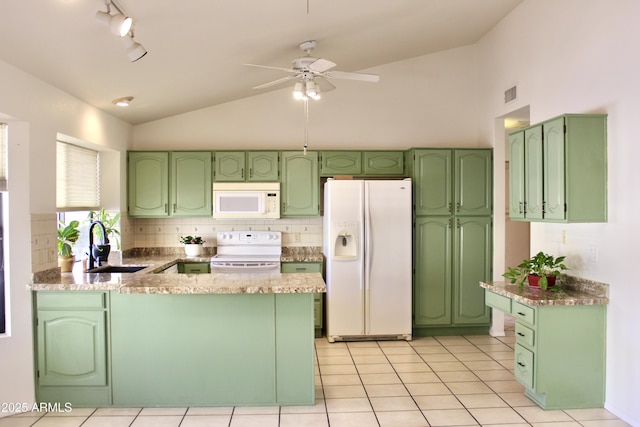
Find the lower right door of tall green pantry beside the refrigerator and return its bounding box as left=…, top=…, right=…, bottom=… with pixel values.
left=453, top=216, right=493, bottom=325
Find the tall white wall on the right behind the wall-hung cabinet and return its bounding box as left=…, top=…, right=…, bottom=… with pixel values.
left=478, top=0, right=640, bottom=425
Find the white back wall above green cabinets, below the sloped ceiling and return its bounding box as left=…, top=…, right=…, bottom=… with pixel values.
left=133, top=46, right=484, bottom=150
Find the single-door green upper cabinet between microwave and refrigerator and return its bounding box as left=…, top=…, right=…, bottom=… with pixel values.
left=280, top=151, right=320, bottom=217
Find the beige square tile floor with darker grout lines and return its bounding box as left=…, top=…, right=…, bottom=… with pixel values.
left=0, top=324, right=628, bottom=427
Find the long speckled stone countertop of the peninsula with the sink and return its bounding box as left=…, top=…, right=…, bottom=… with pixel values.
left=27, top=255, right=327, bottom=294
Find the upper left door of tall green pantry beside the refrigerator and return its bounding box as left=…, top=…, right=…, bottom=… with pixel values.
left=413, top=150, right=453, bottom=216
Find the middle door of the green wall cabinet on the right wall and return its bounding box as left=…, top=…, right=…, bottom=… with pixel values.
left=524, top=125, right=543, bottom=219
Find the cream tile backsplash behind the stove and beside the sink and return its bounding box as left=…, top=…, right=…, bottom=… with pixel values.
left=31, top=212, right=322, bottom=272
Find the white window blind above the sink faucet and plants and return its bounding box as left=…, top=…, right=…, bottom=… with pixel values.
left=56, top=141, right=100, bottom=211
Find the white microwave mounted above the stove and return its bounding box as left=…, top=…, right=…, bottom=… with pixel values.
left=213, top=182, right=280, bottom=219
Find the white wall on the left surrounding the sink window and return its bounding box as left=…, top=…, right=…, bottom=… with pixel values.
left=0, top=61, right=131, bottom=416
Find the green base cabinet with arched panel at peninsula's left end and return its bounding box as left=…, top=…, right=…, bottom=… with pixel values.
left=34, top=291, right=111, bottom=406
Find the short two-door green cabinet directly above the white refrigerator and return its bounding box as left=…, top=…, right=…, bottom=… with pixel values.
left=320, top=151, right=404, bottom=176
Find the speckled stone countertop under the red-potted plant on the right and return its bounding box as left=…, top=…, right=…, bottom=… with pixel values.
left=480, top=276, right=609, bottom=306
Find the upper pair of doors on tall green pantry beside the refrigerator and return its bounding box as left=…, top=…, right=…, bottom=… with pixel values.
left=411, top=149, right=493, bottom=216
